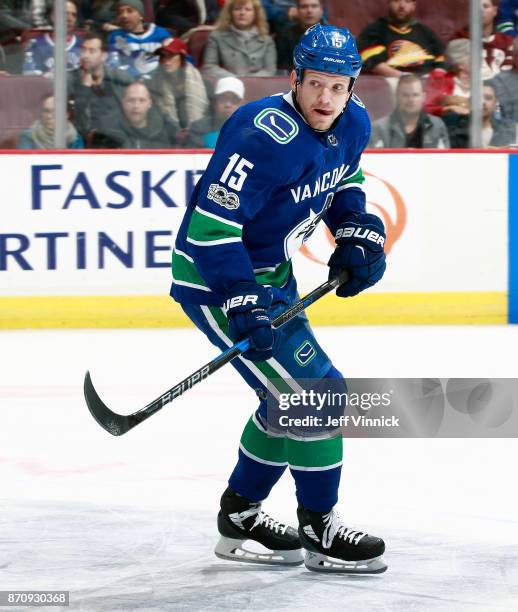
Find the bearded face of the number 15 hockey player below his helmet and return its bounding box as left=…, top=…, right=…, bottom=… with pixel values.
left=291, top=70, right=351, bottom=131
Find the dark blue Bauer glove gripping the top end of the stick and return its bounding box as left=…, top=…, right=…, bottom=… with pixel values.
left=328, top=213, right=386, bottom=297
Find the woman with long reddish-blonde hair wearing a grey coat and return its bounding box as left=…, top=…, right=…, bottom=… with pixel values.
left=203, top=0, right=277, bottom=78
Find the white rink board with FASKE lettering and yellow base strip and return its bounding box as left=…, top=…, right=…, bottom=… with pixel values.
left=0, top=151, right=518, bottom=329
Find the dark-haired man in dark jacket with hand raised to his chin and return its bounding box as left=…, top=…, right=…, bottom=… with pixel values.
left=68, top=32, right=133, bottom=140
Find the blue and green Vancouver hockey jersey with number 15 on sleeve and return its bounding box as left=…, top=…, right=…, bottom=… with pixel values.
left=171, top=92, right=370, bottom=306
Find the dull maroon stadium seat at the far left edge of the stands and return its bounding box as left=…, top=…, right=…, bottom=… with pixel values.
left=0, top=76, right=52, bottom=149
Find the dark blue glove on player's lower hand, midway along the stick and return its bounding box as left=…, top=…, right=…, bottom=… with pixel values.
left=225, top=282, right=275, bottom=361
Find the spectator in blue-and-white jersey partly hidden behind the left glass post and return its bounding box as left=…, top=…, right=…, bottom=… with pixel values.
left=23, top=0, right=81, bottom=77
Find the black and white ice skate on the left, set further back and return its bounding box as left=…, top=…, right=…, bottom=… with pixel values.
left=214, top=488, right=304, bottom=565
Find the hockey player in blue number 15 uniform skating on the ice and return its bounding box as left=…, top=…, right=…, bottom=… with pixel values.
left=171, top=24, right=387, bottom=573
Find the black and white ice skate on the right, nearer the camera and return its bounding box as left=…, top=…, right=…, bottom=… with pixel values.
left=297, top=506, right=387, bottom=574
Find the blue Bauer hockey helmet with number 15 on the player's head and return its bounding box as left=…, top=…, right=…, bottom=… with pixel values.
left=293, top=23, right=362, bottom=82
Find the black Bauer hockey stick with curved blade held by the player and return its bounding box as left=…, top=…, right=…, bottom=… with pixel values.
left=84, top=271, right=348, bottom=436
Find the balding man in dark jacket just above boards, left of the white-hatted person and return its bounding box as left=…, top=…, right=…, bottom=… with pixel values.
left=92, top=83, right=178, bottom=149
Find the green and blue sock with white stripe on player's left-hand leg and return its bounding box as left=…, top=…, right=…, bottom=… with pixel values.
left=228, top=414, right=288, bottom=501
